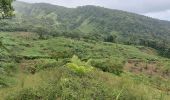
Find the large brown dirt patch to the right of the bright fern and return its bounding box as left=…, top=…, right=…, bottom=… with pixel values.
left=124, top=59, right=170, bottom=78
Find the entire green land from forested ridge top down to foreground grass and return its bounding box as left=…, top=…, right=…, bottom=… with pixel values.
left=0, top=1, right=170, bottom=100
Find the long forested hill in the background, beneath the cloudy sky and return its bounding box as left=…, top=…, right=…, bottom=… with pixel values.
left=0, top=1, right=170, bottom=56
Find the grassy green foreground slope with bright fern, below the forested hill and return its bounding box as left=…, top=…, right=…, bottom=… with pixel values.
left=0, top=32, right=170, bottom=100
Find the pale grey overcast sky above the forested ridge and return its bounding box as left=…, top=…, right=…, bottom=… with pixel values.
left=18, top=0, right=170, bottom=21
